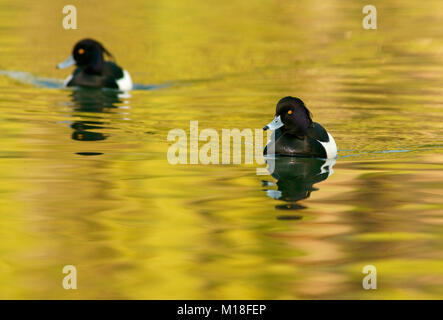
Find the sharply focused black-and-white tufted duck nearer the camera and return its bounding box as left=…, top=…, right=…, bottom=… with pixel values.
left=263, top=97, right=337, bottom=159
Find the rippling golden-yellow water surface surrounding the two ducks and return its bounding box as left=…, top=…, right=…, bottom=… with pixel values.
left=0, top=0, right=443, bottom=299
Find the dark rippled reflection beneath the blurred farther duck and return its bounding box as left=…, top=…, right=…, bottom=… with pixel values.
left=71, top=88, right=129, bottom=141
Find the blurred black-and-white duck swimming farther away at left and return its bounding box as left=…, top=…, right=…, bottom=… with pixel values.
left=57, top=39, right=133, bottom=91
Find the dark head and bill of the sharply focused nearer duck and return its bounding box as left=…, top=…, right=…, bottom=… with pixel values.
left=263, top=97, right=312, bottom=136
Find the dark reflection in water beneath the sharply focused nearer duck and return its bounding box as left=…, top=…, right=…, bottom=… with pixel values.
left=262, top=157, right=336, bottom=219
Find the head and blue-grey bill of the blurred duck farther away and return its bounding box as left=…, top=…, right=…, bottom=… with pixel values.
left=57, top=39, right=112, bottom=74
